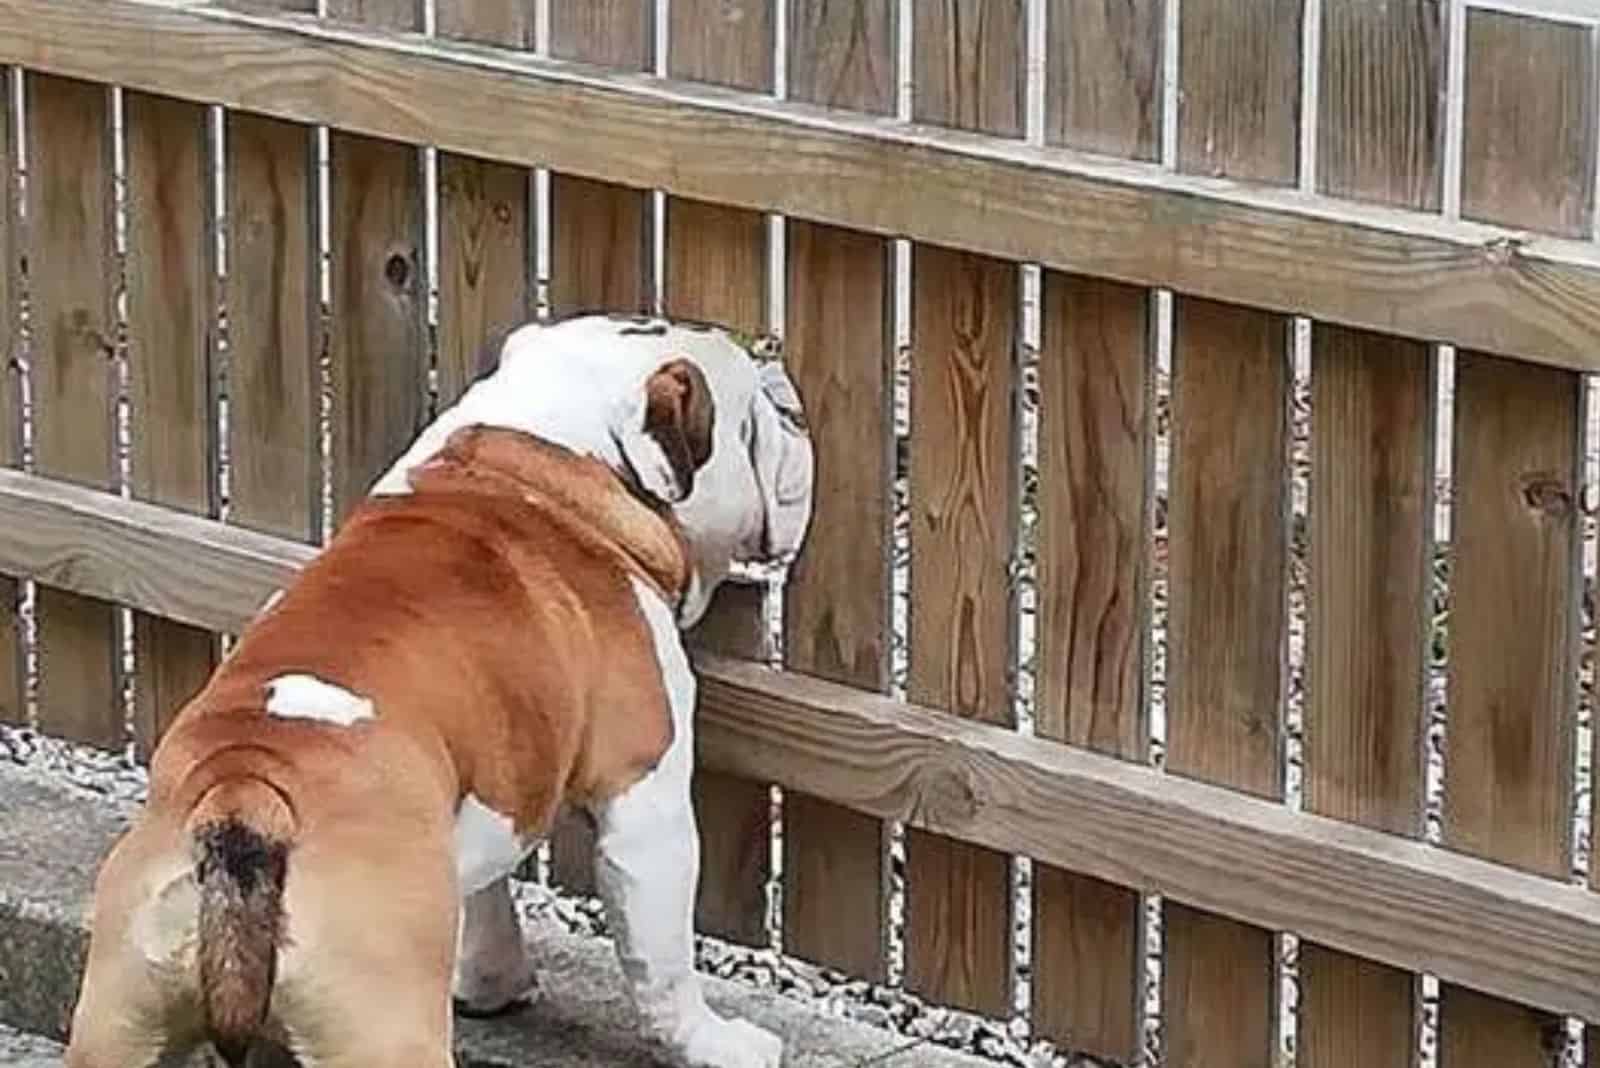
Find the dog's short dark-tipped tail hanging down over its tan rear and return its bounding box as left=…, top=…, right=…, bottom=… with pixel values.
left=189, top=777, right=294, bottom=1068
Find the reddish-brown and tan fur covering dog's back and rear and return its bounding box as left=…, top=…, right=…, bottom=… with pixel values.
left=67, top=427, right=686, bottom=1068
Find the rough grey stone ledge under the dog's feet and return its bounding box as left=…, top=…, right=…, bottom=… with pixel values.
left=0, top=764, right=992, bottom=1068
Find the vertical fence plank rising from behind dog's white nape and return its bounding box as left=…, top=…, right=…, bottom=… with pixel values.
left=438, top=0, right=533, bottom=408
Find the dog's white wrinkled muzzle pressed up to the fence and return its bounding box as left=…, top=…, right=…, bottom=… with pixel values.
left=750, top=361, right=816, bottom=563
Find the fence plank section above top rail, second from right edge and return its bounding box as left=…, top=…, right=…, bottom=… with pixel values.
left=1317, top=0, right=1445, bottom=211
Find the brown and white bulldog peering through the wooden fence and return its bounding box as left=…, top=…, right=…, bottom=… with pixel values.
left=67, top=317, right=813, bottom=1068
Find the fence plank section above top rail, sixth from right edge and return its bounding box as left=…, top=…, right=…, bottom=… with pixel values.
left=789, top=0, right=898, bottom=115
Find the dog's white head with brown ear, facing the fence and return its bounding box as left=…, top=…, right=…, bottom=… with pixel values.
left=483, top=315, right=816, bottom=625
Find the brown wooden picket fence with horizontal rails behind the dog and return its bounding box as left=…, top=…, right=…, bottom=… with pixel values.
left=0, top=0, right=1600, bottom=1068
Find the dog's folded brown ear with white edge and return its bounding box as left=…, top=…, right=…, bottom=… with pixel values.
left=621, top=358, right=717, bottom=504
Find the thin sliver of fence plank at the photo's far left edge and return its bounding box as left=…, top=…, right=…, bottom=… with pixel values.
left=0, top=67, right=18, bottom=723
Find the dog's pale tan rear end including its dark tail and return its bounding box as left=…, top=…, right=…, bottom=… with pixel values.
left=66, top=735, right=456, bottom=1068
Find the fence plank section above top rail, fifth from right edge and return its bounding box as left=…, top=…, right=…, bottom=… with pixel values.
left=912, top=0, right=1027, bottom=137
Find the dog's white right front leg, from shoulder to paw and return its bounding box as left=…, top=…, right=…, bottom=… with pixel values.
left=595, top=575, right=782, bottom=1068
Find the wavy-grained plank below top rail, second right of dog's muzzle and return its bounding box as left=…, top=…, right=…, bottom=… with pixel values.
left=906, top=246, right=1018, bottom=1015
